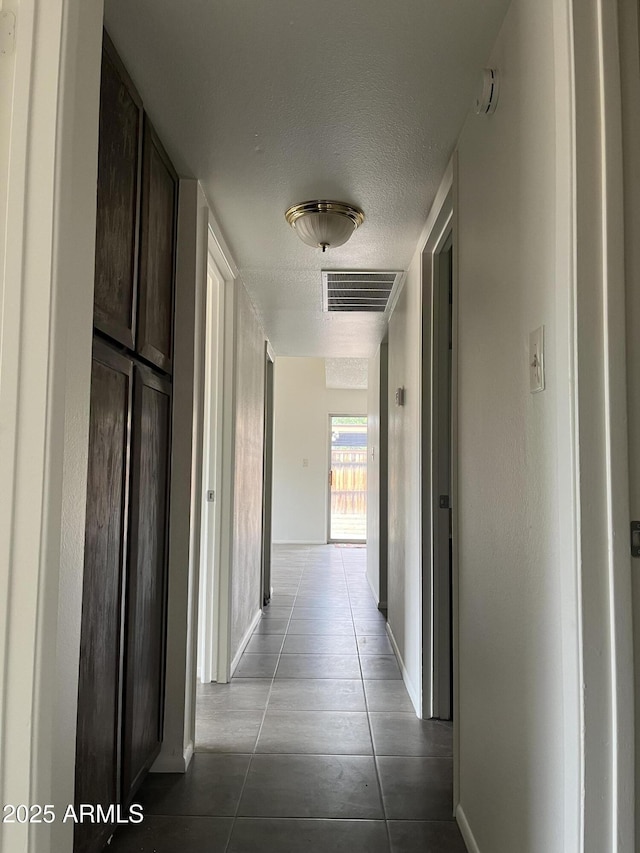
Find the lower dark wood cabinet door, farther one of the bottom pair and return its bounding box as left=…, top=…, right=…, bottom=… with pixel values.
left=123, top=366, right=171, bottom=802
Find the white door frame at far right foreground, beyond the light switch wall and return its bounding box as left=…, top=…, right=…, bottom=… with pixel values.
left=554, top=0, right=637, bottom=853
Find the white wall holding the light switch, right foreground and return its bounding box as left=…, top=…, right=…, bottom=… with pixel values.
left=457, top=0, right=581, bottom=853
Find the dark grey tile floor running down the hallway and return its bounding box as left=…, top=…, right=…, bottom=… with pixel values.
left=108, top=546, right=466, bottom=853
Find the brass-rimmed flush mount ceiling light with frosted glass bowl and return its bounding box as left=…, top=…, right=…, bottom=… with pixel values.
left=284, top=201, right=364, bottom=252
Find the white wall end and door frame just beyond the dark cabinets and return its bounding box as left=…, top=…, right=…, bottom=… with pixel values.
left=160, top=188, right=238, bottom=773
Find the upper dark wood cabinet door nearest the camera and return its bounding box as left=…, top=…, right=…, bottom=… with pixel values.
left=94, top=33, right=143, bottom=349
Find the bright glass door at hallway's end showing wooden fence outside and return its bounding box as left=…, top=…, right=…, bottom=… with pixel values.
left=328, top=415, right=367, bottom=543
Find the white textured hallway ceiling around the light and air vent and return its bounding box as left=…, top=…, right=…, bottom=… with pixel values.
left=105, top=0, right=508, bottom=357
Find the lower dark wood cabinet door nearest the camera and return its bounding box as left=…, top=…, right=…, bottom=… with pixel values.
left=74, top=339, right=133, bottom=853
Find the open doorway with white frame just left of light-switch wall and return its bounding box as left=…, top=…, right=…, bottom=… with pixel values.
left=421, top=180, right=457, bottom=724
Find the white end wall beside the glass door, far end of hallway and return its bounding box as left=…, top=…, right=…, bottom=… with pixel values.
left=273, top=358, right=367, bottom=544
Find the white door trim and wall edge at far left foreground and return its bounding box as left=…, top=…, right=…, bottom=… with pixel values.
left=0, top=0, right=102, bottom=853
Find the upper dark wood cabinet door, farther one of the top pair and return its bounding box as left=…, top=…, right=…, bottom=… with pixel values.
left=136, top=118, right=178, bottom=373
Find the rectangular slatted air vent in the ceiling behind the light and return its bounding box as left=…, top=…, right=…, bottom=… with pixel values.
left=322, top=270, right=402, bottom=314
